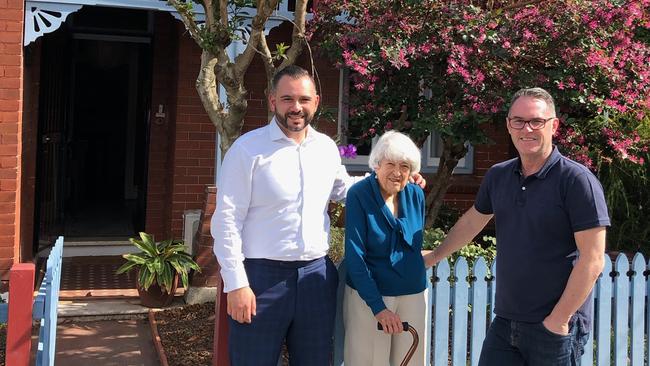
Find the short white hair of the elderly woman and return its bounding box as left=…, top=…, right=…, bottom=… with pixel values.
left=368, top=131, right=421, bottom=174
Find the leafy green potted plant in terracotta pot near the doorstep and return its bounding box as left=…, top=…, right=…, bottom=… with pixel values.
left=116, top=232, right=201, bottom=307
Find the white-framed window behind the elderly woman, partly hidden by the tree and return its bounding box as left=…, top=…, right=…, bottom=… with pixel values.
left=338, top=69, right=474, bottom=174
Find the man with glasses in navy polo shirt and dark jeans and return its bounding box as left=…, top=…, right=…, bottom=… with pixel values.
left=425, top=88, right=610, bottom=366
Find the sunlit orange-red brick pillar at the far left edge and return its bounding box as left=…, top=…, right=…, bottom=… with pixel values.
left=0, top=0, right=24, bottom=280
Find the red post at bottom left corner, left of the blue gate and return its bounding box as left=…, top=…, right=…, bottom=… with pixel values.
left=5, top=263, right=35, bottom=366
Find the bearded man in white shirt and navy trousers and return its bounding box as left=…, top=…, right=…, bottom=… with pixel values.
left=211, top=66, right=353, bottom=366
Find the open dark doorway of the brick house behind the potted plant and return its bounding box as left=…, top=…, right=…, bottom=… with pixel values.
left=64, top=38, right=149, bottom=238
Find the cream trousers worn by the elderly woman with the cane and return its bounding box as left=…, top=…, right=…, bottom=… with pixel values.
left=343, top=285, right=429, bottom=366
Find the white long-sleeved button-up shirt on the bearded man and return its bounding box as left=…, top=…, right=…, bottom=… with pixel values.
left=210, top=118, right=354, bottom=292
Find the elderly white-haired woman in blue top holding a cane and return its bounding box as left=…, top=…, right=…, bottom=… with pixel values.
left=343, top=131, right=429, bottom=366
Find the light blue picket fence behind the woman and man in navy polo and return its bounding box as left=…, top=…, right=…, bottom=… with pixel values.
left=334, top=253, right=650, bottom=366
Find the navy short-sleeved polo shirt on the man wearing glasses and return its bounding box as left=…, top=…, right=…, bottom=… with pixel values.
left=474, top=147, right=610, bottom=329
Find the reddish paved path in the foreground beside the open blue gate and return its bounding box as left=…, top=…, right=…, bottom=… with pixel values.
left=55, top=318, right=160, bottom=366
